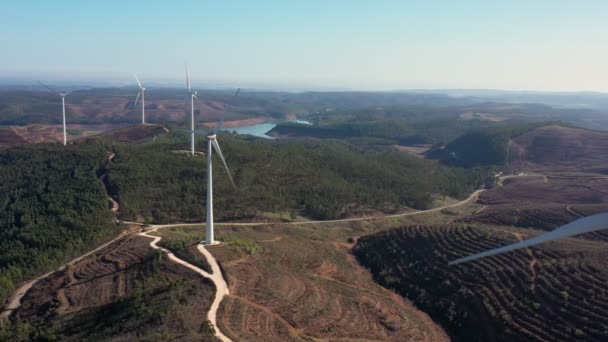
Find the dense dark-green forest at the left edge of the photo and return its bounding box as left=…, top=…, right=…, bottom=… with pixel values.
left=0, top=142, right=118, bottom=301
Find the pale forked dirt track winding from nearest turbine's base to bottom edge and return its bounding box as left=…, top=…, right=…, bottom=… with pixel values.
left=138, top=228, right=232, bottom=342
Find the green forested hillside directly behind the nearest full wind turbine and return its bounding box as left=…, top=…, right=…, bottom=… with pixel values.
left=108, top=130, right=490, bottom=222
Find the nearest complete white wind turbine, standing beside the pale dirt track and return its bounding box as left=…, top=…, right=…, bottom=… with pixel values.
left=204, top=88, right=241, bottom=245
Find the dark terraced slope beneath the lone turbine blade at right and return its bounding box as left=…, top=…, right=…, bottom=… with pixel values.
left=353, top=226, right=608, bottom=341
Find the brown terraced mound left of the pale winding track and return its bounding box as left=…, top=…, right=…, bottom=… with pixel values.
left=10, top=236, right=215, bottom=341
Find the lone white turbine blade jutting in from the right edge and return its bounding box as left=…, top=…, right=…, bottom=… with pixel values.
left=448, top=213, right=608, bottom=265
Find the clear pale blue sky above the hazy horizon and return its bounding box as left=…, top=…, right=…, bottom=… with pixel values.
left=0, top=0, right=608, bottom=92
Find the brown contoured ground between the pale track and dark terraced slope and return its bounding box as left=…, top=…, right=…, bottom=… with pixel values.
left=210, top=227, right=447, bottom=341
